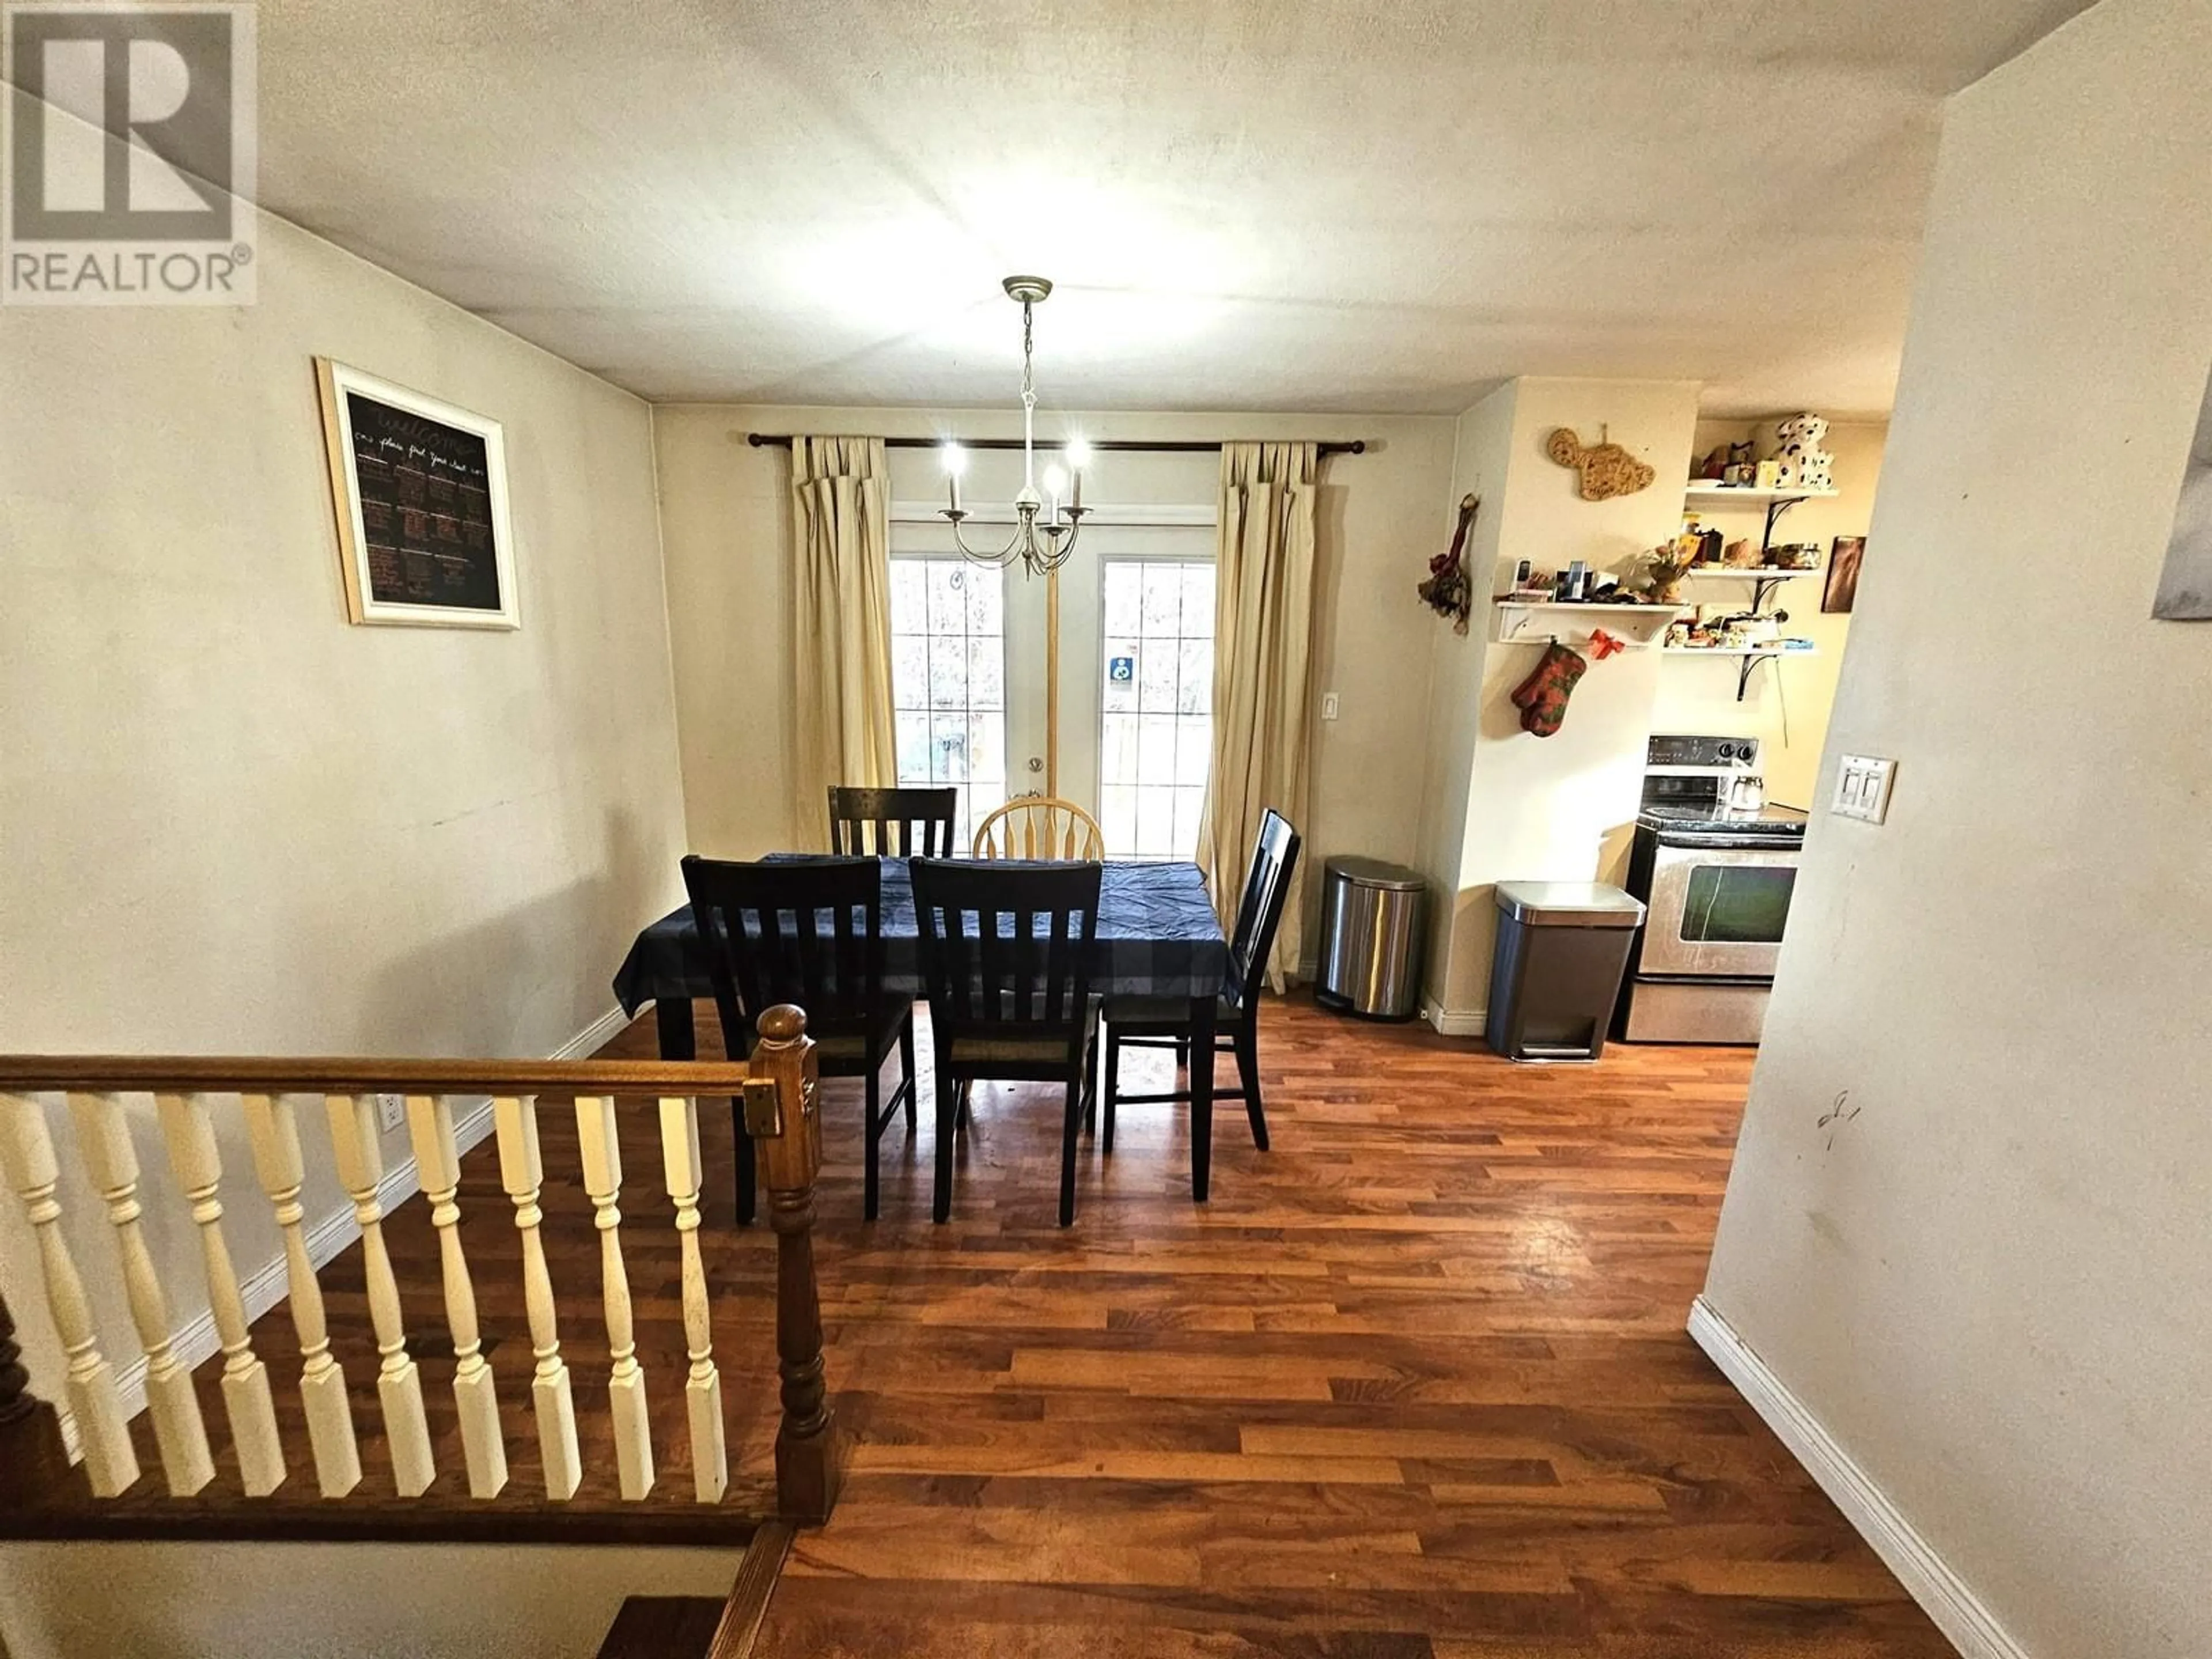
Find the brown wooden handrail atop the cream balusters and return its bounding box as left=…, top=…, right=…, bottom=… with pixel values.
left=0, top=1055, right=759, bottom=1097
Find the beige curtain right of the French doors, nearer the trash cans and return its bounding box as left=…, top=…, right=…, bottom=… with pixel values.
left=1199, top=442, right=1320, bottom=991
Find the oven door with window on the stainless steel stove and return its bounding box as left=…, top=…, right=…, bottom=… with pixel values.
left=1637, top=836, right=1798, bottom=980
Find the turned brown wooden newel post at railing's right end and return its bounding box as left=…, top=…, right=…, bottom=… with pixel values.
left=745, top=1004, right=838, bottom=1527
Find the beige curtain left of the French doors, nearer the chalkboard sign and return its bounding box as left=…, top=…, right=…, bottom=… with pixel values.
left=791, top=438, right=898, bottom=850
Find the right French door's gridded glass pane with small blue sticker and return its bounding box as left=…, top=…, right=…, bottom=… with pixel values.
left=1099, top=560, right=1214, bottom=858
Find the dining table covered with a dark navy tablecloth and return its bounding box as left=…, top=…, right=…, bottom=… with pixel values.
left=615, top=854, right=1230, bottom=1203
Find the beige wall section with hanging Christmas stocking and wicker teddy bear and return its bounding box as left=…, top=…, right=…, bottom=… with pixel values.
left=1422, top=376, right=1696, bottom=1031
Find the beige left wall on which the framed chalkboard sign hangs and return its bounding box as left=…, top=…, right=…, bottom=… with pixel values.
left=0, top=219, right=684, bottom=1396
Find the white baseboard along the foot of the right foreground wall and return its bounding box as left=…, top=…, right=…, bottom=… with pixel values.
left=1690, top=1296, right=2028, bottom=1659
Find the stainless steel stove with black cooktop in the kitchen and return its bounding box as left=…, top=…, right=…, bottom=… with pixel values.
left=1612, top=734, right=1805, bottom=1044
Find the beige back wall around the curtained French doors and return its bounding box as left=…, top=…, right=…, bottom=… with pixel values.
left=655, top=405, right=1453, bottom=942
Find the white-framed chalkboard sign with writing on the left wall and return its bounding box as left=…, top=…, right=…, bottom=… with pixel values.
left=314, top=356, right=522, bottom=628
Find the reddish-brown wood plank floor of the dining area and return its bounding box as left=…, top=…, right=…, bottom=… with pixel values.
left=52, top=1002, right=1951, bottom=1659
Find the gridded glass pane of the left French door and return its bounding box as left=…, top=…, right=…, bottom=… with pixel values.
left=892, top=558, right=1006, bottom=847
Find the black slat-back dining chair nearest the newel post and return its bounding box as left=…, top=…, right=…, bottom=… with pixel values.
left=684, top=854, right=916, bottom=1224
